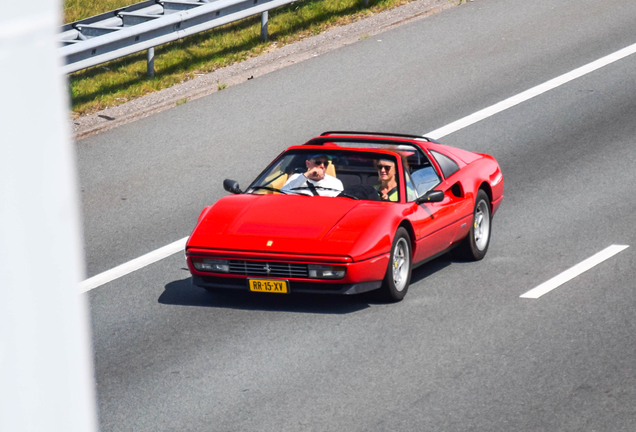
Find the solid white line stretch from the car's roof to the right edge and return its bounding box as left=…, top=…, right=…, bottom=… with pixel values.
left=424, top=44, right=636, bottom=139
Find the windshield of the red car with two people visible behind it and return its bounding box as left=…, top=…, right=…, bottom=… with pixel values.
left=247, top=149, right=402, bottom=202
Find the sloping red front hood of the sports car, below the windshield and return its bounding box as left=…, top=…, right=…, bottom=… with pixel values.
left=188, top=194, right=391, bottom=259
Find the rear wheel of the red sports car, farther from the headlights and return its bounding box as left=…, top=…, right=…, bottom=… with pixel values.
left=458, top=189, right=492, bottom=261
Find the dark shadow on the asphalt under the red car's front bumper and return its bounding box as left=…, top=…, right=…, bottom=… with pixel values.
left=158, top=278, right=379, bottom=314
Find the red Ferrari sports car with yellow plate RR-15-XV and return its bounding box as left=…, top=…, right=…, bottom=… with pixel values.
left=186, top=132, right=504, bottom=301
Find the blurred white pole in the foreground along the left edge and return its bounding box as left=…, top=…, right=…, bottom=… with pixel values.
left=0, top=0, right=97, bottom=432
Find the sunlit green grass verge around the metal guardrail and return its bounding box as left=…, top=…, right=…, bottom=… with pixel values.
left=64, top=0, right=442, bottom=116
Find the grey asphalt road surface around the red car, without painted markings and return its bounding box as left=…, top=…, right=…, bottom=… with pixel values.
left=77, top=0, right=636, bottom=431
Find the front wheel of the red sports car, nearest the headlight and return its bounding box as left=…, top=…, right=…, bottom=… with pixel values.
left=381, top=227, right=412, bottom=303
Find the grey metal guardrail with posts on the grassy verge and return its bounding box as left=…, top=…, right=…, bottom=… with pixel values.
left=58, top=0, right=297, bottom=76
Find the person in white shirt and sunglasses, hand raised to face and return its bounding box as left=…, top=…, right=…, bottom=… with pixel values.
left=281, top=154, right=344, bottom=197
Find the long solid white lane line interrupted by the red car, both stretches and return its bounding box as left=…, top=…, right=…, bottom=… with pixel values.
left=80, top=44, right=636, bottom=292
